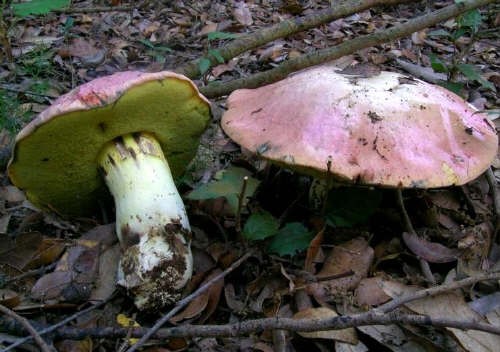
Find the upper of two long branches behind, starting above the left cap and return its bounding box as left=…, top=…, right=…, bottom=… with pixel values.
left=176, top=0, right=416, bottom=78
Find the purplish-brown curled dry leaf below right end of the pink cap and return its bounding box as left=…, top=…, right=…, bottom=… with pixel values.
left=403, top=232, right=459, bottom=263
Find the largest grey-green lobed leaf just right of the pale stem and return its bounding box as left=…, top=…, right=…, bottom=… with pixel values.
left=187, top=167, right=260, bottom=214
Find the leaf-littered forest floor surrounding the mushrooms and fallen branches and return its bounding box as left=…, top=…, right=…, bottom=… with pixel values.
left=0, top=0, right=500, bottom=352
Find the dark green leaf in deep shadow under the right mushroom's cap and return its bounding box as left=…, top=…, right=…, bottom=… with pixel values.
left=325, top=187, right=382, bottom=227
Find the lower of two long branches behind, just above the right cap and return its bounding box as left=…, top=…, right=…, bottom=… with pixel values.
left=200, top=0, right=495, bottom=98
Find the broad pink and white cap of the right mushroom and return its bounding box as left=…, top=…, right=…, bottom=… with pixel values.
left=222, top=66, right=498, bottom=188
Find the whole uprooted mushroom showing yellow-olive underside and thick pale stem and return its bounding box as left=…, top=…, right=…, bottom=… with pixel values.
left=8, top=71, right=210, bottom=309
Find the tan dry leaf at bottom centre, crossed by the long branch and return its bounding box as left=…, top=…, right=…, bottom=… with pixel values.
left=293, top=307, right=358, bottom=344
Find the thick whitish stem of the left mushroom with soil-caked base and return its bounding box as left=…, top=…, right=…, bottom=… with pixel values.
left=99, top=133, right=193, bottom=309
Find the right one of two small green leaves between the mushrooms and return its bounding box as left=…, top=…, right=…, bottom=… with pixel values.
left=267, top=222, right=314, bottom=256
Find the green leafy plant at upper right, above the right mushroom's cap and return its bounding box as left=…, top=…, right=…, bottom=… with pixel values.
left=429, top=7, right=496, bottom=94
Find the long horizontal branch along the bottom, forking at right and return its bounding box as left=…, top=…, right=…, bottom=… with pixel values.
left=4, top=270, right=500, bottom=342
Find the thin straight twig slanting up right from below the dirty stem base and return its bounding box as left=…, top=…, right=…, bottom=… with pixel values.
left=128, top=251, right=253, bottom=352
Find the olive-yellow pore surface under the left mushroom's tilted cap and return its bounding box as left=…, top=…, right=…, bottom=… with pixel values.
left=9, top=78, right=210, bottom=215
